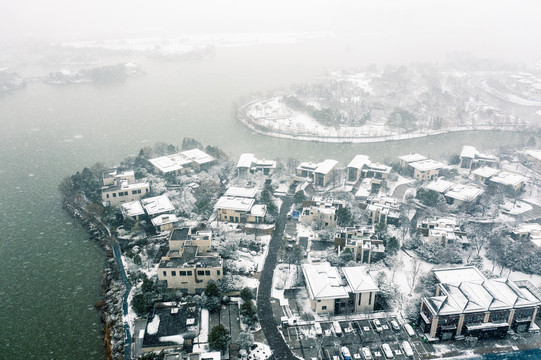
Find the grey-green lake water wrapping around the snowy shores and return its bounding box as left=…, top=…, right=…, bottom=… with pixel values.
left=0, top=41, right=538, bottom=359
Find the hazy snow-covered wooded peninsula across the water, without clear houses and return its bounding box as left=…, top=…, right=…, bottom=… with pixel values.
left=238, top=63, right=541, bottom=143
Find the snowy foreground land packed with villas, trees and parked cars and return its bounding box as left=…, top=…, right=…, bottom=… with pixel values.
left=60, top=137, right=541, bottom=359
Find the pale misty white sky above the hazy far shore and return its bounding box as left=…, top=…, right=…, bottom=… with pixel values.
left=0, top=0, right=541, bottom=60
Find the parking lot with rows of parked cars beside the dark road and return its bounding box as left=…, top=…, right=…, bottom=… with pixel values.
left=284, top=317, right=433, bottom=360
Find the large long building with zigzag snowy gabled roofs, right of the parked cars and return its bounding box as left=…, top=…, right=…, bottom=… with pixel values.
left=419, top=266, right=541, bottom=341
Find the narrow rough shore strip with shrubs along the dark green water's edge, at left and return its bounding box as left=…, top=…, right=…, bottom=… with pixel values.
left=63, top=199, right=126, bottom=360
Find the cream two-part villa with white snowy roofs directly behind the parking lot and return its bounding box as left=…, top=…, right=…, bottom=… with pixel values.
left=302, top=262, right=379, bottom=315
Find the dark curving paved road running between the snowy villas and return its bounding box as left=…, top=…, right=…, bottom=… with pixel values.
left=257, top=196, right=296, bottom=360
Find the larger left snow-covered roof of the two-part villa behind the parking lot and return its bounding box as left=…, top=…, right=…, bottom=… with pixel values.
left=302, top=262, right=349, bottom=300
